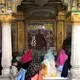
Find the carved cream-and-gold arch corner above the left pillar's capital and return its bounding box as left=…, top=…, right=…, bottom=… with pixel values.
left=0, top=0, right=23, bottom=14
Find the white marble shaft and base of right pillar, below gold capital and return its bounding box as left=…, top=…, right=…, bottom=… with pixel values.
left=71, top=25, right=80, bottom=80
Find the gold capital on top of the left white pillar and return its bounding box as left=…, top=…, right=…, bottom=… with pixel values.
left=0, top=14, right=15, bottom=22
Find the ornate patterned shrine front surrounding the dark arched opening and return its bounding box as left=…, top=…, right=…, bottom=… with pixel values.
left=28, top=23, right=56, bottom=59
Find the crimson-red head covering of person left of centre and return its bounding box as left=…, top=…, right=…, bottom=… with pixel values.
left=21, top=50, right=32, bottom=64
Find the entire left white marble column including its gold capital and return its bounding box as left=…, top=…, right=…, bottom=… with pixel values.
left=0, top=15, right=12, bottom=77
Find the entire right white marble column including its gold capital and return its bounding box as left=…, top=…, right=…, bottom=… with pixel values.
left=70, top=11, right=80, bottom=80
